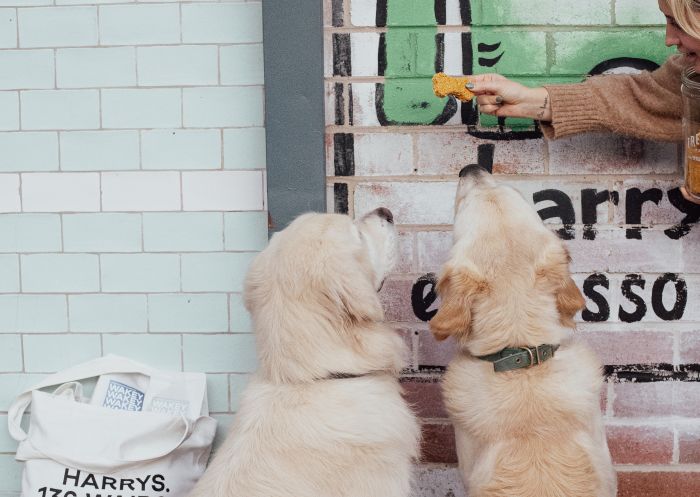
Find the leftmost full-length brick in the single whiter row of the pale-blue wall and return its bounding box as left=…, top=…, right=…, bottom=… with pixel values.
left=22, top=173, right=100, bottom=212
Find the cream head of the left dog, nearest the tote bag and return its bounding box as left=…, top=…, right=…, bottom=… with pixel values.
left=245, top=208, right=397, bottom=381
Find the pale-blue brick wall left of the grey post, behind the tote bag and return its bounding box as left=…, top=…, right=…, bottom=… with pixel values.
left=0, top=0, right=267, bottom=495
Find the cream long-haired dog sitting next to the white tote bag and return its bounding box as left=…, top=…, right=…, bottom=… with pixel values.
left=191, top=208, right=420, bottom=497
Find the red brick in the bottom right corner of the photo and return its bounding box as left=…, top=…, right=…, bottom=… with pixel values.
left=617, top=471, right=700, bottom=497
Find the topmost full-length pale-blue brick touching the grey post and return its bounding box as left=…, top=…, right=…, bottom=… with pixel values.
left=182, top=2, right=262, bottom=43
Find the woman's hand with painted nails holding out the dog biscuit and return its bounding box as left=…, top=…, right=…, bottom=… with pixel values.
left=467, top=74, right=552, bottom=121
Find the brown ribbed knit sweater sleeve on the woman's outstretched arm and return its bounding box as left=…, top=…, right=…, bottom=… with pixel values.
left=541, top=55, right=684, bottom=141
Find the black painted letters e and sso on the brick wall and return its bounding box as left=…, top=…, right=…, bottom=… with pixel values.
left=411, top=273, right=688, bottom=323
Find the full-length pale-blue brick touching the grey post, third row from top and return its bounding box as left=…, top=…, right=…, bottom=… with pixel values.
left=183, top=87, right=265, bottom=128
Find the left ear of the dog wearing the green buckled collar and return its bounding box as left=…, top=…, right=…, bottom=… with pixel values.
left=430, top=266, right=486, bottom=340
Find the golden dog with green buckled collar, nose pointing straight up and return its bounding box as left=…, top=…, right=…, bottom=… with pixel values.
left=430, top=166, right=616, bottom=497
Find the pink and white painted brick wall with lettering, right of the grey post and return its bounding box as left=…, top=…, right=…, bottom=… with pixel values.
left=324, top=0, right=700, bottom=497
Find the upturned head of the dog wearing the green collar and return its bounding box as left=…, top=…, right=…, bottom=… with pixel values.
left=430, top=166, right=585, bottom=347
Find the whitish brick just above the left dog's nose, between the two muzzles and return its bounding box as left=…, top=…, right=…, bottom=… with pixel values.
left=355, top=181, right=457, bottom=224
